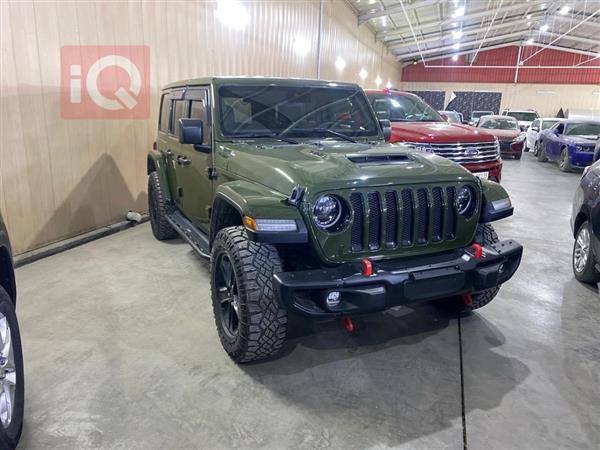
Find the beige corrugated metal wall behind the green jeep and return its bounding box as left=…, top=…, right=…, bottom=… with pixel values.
left=0, top=0, right=400, bottom=253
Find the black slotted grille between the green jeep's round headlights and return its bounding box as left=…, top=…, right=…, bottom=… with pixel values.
left=350, top=186, right=456, bottom=252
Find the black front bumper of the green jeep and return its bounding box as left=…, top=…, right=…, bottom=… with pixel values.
left=273, top=240, right=523, bottom=317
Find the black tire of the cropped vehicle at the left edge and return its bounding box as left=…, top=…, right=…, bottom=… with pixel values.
left=0, top=287, right=25, bottom=449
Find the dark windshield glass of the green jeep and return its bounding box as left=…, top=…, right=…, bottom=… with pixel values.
left=219, top=85, right=380, bottom=139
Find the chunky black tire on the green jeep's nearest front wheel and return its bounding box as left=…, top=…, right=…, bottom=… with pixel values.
left=211, top=226, right=288, bottom=363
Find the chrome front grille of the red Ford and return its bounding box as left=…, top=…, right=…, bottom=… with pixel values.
left=405, top=141, right=500, bottom=164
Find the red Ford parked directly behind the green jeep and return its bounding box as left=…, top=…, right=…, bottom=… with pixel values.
left=365, top=89, right=502, bottom=183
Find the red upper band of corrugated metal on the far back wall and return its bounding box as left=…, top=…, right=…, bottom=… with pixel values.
left=402, top=46, right=600, bottom=84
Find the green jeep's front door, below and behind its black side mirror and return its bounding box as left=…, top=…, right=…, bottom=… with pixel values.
left=174, top=87, right=213, bottom=232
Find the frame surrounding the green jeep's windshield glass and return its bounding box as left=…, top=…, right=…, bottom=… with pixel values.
left=213, top=83, right=384, bottom=142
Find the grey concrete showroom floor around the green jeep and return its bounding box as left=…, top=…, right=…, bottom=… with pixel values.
left=17, top=154, right=600, bottom=450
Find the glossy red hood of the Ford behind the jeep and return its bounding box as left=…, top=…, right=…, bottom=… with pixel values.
left=391, top=122, right=494, bottom=144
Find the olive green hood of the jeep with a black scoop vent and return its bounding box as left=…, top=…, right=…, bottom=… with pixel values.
left=217, top=141, right=473, bottom=196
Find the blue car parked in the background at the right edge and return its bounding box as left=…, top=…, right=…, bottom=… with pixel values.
left=538, top=120, right=600, bottom=172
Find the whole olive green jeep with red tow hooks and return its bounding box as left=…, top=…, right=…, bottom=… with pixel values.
left=148, top=78, right=523, bottom=362
